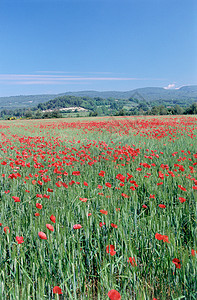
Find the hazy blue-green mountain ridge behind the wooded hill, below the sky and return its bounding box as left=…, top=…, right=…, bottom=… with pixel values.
left=0, top=85, right=197, bottom=110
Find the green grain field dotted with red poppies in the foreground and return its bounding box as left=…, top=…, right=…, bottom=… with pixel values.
left=0, top=116, right=197, bottom=300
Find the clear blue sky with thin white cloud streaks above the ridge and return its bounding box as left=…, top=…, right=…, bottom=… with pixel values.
left=0, top=0, right=197, bottom=96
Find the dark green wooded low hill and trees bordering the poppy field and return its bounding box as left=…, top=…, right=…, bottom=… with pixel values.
left=0, top=96, right=197, bottom=119
